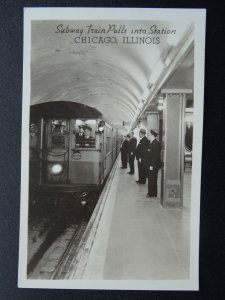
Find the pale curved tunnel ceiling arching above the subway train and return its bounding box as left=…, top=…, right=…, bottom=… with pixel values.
left=31, top=21, right=193, bottom=127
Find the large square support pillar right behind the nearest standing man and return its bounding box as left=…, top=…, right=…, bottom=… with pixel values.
left=161, top=93, right=186, bottom=208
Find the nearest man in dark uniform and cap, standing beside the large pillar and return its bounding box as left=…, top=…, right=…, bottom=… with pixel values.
left=147, top=130, right=161, bottom=197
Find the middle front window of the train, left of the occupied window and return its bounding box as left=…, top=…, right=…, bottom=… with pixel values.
left=48, top=119, right=69, bottom=149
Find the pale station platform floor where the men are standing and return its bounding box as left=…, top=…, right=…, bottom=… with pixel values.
left=67, top=157, right=191, bottom=280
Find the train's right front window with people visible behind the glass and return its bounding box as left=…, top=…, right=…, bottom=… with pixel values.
left=74, top=119, right=96, bottom=148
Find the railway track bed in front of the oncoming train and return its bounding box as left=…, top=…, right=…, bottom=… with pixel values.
left=27, top=190, right=98, bottom=279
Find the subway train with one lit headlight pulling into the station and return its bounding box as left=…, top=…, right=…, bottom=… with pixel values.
left=29, top=101, right=121, bottom=212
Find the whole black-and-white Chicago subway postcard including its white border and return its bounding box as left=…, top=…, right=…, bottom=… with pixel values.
left=18, top=8, right=205, bottom=290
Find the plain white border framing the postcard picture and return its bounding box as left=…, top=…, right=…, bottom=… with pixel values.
left=18, top=8, right=206, bottom=290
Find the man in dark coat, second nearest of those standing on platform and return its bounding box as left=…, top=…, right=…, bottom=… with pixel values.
left=136, top=129, right=149, bottom=184
